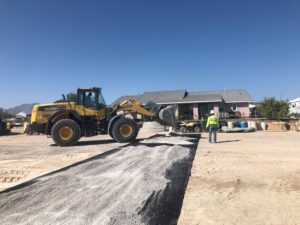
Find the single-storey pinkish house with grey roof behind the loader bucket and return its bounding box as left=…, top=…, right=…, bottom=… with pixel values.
left=113, top=89, right=253, bottom=119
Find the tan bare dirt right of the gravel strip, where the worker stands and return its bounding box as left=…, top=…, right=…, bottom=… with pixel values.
left=178, top=131, right=300, bottom=225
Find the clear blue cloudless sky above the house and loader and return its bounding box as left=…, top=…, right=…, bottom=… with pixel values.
left=0, top=0, right=300, bottom=108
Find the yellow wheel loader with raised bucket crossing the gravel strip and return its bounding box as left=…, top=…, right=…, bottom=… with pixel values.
left=28, top=87, right=176, bottom=146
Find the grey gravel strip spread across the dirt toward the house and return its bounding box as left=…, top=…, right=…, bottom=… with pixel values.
left=0, top=136, right=196, bottom=225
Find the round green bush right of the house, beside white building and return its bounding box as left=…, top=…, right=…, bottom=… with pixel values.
left=258, top=97, right=289, bottom=120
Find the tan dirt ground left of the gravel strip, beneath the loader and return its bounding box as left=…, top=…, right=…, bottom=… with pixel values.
left=0, top=129, right=154, bottom=191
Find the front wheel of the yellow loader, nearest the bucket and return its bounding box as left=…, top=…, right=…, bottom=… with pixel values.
left=112, top=117, right=139, bottom=142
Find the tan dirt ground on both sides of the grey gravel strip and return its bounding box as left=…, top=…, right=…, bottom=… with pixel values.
left=0, top=128, right=300, bottom=225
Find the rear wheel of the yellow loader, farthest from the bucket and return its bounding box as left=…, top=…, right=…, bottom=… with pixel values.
left=51, top=119, right=81, bottom=147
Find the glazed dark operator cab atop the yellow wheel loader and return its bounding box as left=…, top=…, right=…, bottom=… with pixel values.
left=77, top=88, right=106, bottom=110
